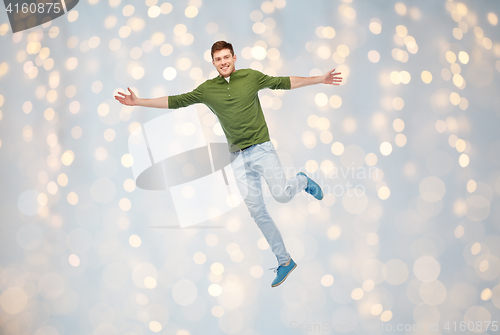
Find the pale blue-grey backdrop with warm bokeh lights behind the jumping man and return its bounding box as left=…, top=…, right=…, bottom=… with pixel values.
left=0, top=0, right=500, bottom=335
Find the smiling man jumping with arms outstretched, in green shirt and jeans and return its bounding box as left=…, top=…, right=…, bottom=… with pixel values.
left=115, top=41, right=342, bottom=287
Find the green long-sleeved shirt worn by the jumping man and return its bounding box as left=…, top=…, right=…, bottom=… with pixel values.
left=168, top=69, right=291, bottom=152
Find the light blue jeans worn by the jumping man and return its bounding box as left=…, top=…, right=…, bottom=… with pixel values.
left=231, top=141, right=307, bottom=265
